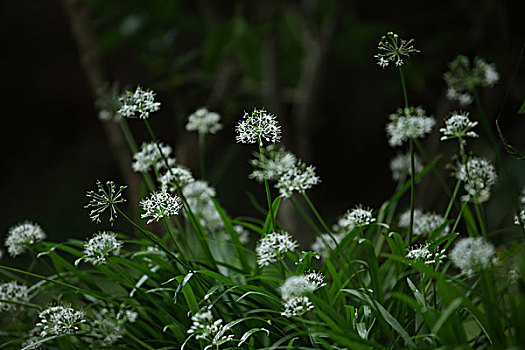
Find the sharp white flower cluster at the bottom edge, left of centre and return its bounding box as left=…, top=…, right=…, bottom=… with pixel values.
left=188, top=310, right=234, bottom=346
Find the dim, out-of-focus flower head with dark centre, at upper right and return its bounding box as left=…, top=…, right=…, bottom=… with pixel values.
left=443, top=55, right=499, bottom=106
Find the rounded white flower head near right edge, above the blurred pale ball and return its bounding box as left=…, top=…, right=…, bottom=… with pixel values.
left=456, top=157, right=498, bottom=203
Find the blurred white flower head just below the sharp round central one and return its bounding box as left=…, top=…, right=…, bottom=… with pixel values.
left=250, top=145, right=297, bottom=183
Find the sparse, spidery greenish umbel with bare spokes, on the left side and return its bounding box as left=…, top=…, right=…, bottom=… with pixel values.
left=84, top=180, right=127, bottom=225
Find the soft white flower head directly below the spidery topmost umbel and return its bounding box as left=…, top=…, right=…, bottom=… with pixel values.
left=386, top=107, right=436, bottom=147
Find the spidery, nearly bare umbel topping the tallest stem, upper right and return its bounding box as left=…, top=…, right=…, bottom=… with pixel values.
left=374, top=32, right=419, bottom=68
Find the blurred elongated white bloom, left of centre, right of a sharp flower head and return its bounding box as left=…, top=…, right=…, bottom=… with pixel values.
left=182, top=180, right=224, bottom=231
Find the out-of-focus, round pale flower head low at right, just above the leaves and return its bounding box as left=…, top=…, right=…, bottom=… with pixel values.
left=449, top=237, right=495, bottom=277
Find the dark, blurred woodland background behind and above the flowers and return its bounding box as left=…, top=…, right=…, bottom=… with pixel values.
left=0, top=0, right=525, bottom=247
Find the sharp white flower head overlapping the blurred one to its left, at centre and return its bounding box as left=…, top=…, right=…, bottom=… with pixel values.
left=275, top=162, right=321, bottom=198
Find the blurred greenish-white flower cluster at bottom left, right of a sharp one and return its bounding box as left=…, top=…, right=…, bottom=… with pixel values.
left=90, top=307, right=138, bottom=347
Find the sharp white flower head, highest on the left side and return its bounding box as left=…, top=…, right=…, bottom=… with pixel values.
left=117, top=86, right=160, bottom=119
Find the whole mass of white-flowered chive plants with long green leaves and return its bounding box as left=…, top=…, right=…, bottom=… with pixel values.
left=0, top=33, right=525, bottom=350
